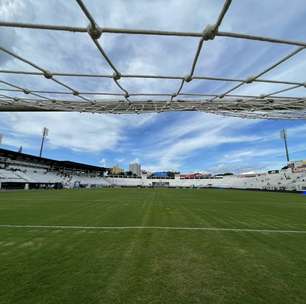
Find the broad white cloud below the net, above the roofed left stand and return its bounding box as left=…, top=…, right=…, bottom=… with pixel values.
left=0, top=112, right=156, bottom=152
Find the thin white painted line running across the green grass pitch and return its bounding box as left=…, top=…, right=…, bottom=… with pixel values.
left=0, top=225, right=306, bottom=234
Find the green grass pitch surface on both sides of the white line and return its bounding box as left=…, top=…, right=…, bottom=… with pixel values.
left=0, top=189, right=306, bottom=304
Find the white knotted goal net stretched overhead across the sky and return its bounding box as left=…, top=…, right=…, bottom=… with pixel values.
left=0, top=0, right=306, bottom=119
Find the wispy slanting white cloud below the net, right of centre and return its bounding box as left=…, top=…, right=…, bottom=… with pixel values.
left=141, top=113, right=260, bottom=170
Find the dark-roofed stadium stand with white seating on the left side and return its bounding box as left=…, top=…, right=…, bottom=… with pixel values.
left=0, top=149, right=110, bottom=189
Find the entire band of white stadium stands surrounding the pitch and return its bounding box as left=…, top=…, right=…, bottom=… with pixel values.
left=0, top=149, right=306, bottom=191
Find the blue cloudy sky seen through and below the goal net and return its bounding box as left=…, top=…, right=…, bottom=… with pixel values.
left=0, top=0, right=306, bottom=173
